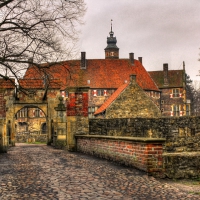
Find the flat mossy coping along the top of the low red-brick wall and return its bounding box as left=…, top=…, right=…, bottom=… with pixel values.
left=75, top=135, right=166, bottom=144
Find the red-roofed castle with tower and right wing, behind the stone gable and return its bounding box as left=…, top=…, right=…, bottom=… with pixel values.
left=0, top=24, right=190, bottom=120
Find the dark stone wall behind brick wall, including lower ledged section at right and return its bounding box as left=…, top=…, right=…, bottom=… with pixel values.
left=89, top=117, right=200, bottom=178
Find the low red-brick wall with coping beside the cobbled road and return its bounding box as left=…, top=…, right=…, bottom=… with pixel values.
left=76, top=135, right=164, bottom=176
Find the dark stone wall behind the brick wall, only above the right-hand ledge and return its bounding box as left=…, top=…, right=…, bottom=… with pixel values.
left=89, top=117, right=200, bottom=152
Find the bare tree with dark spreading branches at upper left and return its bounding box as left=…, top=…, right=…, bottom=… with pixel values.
left=0, top=0, right=85, bottom=87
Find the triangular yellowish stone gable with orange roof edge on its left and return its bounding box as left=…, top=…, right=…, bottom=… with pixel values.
left=95, top=75, right=161, bottom=118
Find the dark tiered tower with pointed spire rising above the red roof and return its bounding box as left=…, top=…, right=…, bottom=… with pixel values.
left=105, top=20, right=119, bottom=59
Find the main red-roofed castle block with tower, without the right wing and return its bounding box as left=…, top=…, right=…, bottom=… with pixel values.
left=23, top=25, right=160, bottom=118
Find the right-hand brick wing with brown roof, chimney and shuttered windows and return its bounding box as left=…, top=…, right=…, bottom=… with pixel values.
left=149, top=63, right=191, bottom=117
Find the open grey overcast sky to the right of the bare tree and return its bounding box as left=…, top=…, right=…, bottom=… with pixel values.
left=79, top=0, right=200, bottom=80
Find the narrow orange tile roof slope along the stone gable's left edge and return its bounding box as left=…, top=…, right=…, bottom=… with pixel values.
left=94, top=83, right=129, bottom=115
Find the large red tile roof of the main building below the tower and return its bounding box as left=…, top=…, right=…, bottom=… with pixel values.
left=24, top=59, right=159, bottom=91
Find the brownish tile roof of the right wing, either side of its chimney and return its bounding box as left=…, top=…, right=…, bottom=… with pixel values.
left=149, top=70, right=185, bottom=88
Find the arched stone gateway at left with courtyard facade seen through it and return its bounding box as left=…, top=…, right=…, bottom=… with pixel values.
left=6, top=102, right=51, bottom=145
